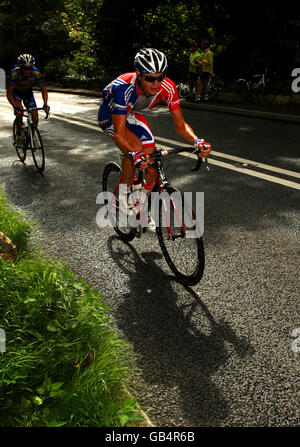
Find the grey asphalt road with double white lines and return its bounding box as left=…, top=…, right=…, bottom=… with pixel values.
left=0, top=93, right=300, bottom=427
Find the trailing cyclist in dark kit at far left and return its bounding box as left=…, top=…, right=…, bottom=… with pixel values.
left=6, top=54, right=50, bottom=144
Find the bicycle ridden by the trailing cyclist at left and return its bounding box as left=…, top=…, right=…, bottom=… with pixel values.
left=13, top=107, right=49, bottom=172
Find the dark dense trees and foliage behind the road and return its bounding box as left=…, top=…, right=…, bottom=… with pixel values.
left=0, top=0, right=300, bottom=82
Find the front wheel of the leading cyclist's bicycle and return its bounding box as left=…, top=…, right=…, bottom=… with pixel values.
left=156, top=186, right=204, bottom=286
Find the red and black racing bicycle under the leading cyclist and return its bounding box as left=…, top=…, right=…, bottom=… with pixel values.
left=103, top=148, right=207, bottom=285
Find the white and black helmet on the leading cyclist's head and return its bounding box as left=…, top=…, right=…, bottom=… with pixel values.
left=134, top=48, right=168, bottom=73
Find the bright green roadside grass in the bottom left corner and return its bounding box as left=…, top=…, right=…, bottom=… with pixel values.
left=0, top=190, right=141, bottom=427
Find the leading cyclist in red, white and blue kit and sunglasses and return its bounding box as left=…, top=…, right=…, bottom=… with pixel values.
left=98, top=48, right=211, bottom=186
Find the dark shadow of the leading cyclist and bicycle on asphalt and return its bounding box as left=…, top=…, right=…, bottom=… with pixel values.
left=109, top=237, right=254, bottom=426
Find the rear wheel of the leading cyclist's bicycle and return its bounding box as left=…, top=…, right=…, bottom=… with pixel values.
left=102, top=162, right=136, bottom=242
